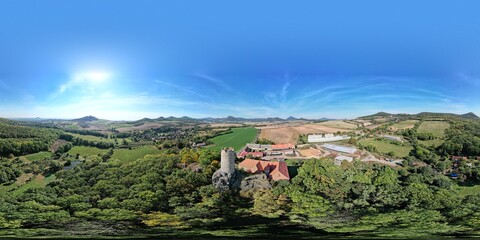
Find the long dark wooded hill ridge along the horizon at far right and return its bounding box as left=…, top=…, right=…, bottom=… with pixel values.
left=358, top=112, right=480, bottom=120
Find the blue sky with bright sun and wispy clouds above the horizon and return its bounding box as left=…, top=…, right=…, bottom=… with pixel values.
left=0, top=0, right=480, bottom=120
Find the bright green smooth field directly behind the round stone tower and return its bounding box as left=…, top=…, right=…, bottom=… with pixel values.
left=211, top=128, right=257, bottom=151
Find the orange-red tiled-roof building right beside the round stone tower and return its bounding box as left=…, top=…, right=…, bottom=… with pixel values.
left=238, top=159, right=290, bottom=181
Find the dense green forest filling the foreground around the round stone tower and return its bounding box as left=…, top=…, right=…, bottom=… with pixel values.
left=0, top=121, right=480, bottom=237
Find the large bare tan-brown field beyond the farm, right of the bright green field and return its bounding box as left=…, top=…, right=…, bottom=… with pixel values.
left=260, top=121, right=357, bottom=144
